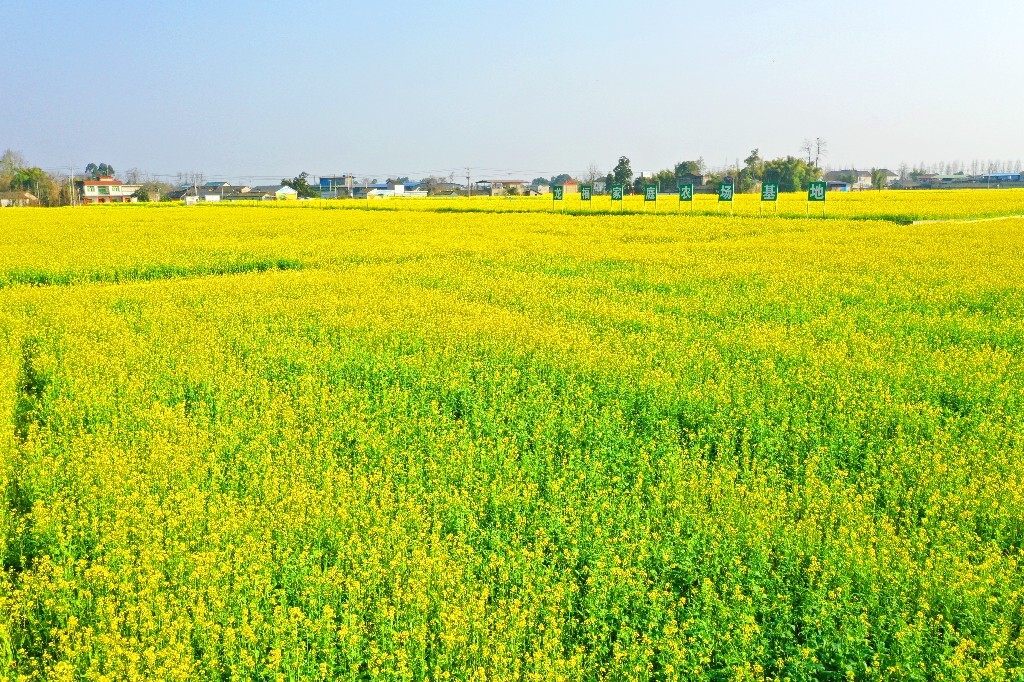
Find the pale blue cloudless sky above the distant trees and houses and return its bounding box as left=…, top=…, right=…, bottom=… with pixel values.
left=0, top=0, right=1024, bottom=179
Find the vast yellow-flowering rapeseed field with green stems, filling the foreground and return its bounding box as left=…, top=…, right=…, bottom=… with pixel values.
left=0, top=204, right=1024, bottom=680
